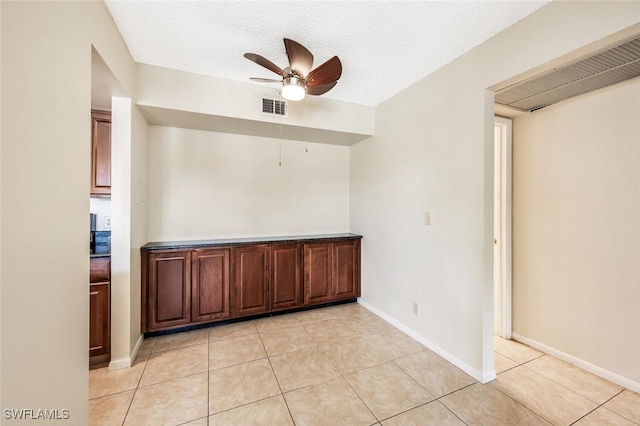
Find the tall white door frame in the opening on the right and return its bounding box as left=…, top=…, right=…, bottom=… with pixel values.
left=493, top=116, right=513, bottom=339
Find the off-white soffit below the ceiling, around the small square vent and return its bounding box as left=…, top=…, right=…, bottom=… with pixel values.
left=137, top=64, right=374, bottom=143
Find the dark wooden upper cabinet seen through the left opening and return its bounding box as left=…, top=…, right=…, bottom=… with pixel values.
left=91, top=110, right=111, bottom=197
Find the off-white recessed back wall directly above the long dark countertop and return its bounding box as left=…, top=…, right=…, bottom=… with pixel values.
left=149, top=126, right=349, bottom=241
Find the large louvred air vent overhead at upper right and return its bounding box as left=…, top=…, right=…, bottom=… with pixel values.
left=495, top=36, right=640, bottom=111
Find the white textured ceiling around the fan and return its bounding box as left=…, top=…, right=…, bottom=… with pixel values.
left=105, top=0, right=547, bottom=105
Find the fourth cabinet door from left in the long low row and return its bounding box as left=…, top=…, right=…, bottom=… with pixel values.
left=270, top=244, right=302, bottom=309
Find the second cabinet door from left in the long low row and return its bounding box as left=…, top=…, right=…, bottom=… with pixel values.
left=191, top=248, right=231, bottom=322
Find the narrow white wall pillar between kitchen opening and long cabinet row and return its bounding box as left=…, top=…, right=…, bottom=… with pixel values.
left=109, top=97, right=148, bottom=369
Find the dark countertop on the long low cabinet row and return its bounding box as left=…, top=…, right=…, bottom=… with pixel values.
left=141, top=233, right=362, bottom=250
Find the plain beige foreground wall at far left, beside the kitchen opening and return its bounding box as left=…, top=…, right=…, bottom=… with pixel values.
left=0, top=2, right=141, bottom=424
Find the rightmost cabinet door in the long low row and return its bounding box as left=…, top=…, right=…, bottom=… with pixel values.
left=332, top=240, right=360, bottom=299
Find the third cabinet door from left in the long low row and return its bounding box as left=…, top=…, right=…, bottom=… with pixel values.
left=234, top=245, right=269, bottom=316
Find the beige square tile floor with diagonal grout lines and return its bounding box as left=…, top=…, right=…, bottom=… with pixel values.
left=89, top=303, right=640, bottom=426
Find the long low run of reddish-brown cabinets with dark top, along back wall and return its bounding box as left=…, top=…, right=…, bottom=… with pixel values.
left=141, top=234, right=362, bottom=333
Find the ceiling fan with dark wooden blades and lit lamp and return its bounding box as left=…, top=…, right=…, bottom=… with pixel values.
left=244, top=38, right=342, bottom=101
